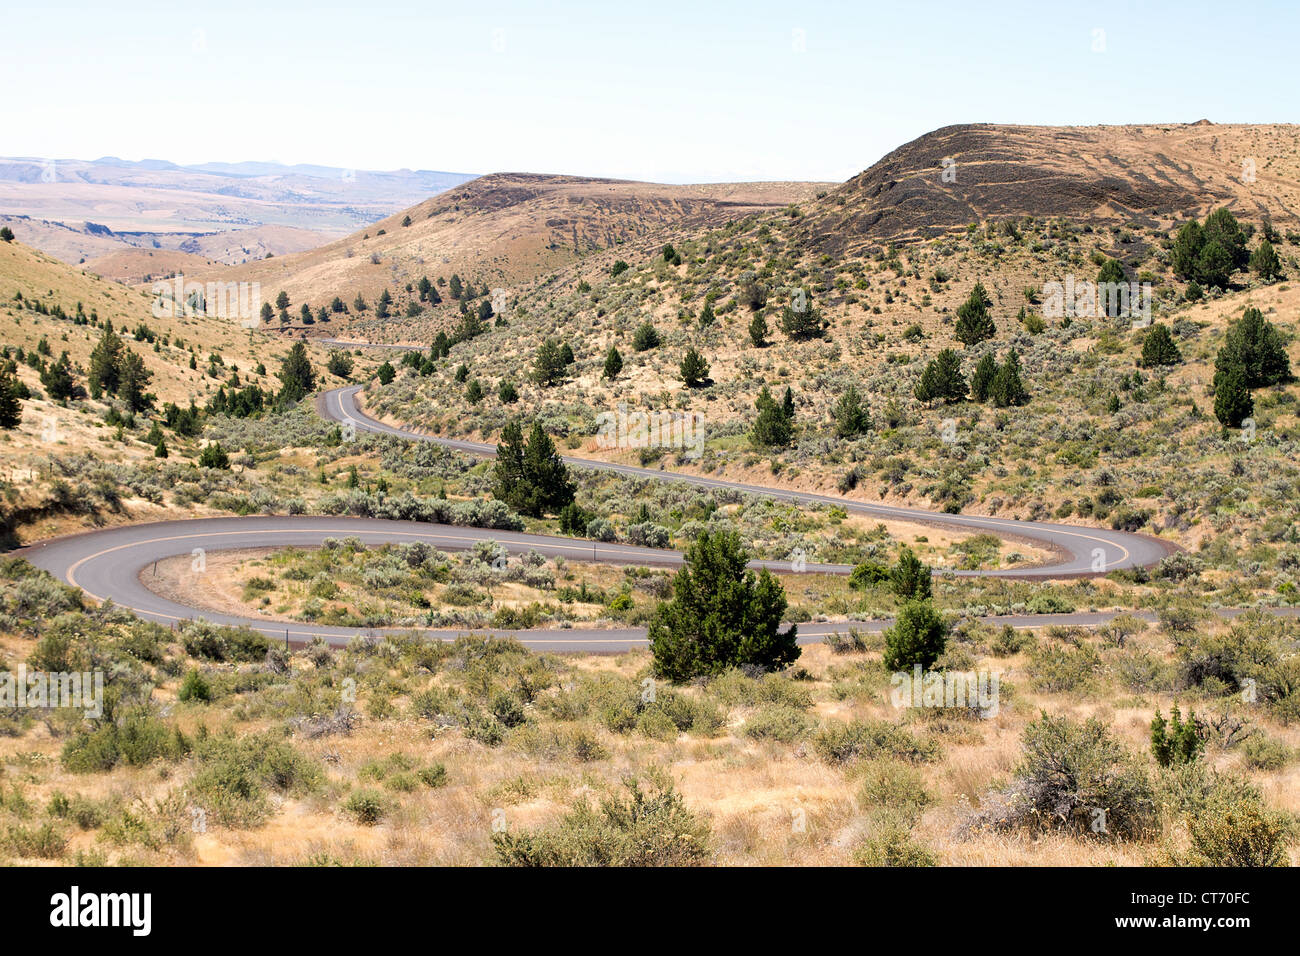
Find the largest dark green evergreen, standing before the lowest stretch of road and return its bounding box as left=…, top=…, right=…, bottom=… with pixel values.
left=649, top=531, right=800, bottom=683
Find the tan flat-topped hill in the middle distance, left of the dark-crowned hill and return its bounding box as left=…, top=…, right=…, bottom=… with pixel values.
left=203, top=173, right=827, bottom=321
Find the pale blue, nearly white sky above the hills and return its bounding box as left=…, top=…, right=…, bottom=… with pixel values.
left=0, top=0, right=1300, bottom=182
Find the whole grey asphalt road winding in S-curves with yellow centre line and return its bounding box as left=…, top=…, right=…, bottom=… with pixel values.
left=17, top=377, right=1177, bottom=652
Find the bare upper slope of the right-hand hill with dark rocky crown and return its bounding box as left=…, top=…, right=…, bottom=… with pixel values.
left=801, top=121, right=1300, bottom=255
